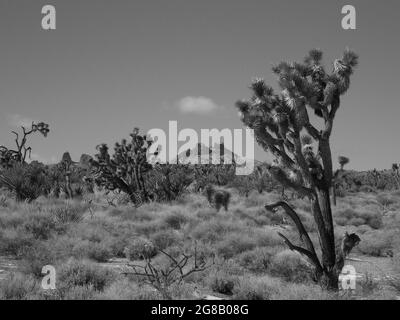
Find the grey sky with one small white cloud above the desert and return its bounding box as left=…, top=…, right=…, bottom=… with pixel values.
left=0, top=0, right=400, bottom=170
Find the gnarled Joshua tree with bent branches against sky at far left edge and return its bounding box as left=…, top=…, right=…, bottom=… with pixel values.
left=0, top=122, right=50, bottom=167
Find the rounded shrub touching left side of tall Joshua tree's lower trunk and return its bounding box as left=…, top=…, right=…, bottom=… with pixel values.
left=270, top=250, right=312, bottom=282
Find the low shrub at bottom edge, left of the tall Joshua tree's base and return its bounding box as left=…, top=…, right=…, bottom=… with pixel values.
left=233, top=276, right=282, bottom=300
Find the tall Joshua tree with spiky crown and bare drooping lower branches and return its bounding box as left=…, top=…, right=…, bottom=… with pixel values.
left=237, top=49, right=358, bottom=289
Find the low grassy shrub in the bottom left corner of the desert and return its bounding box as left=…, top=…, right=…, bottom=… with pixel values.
left=0, top=273, right=39, bottom=300
